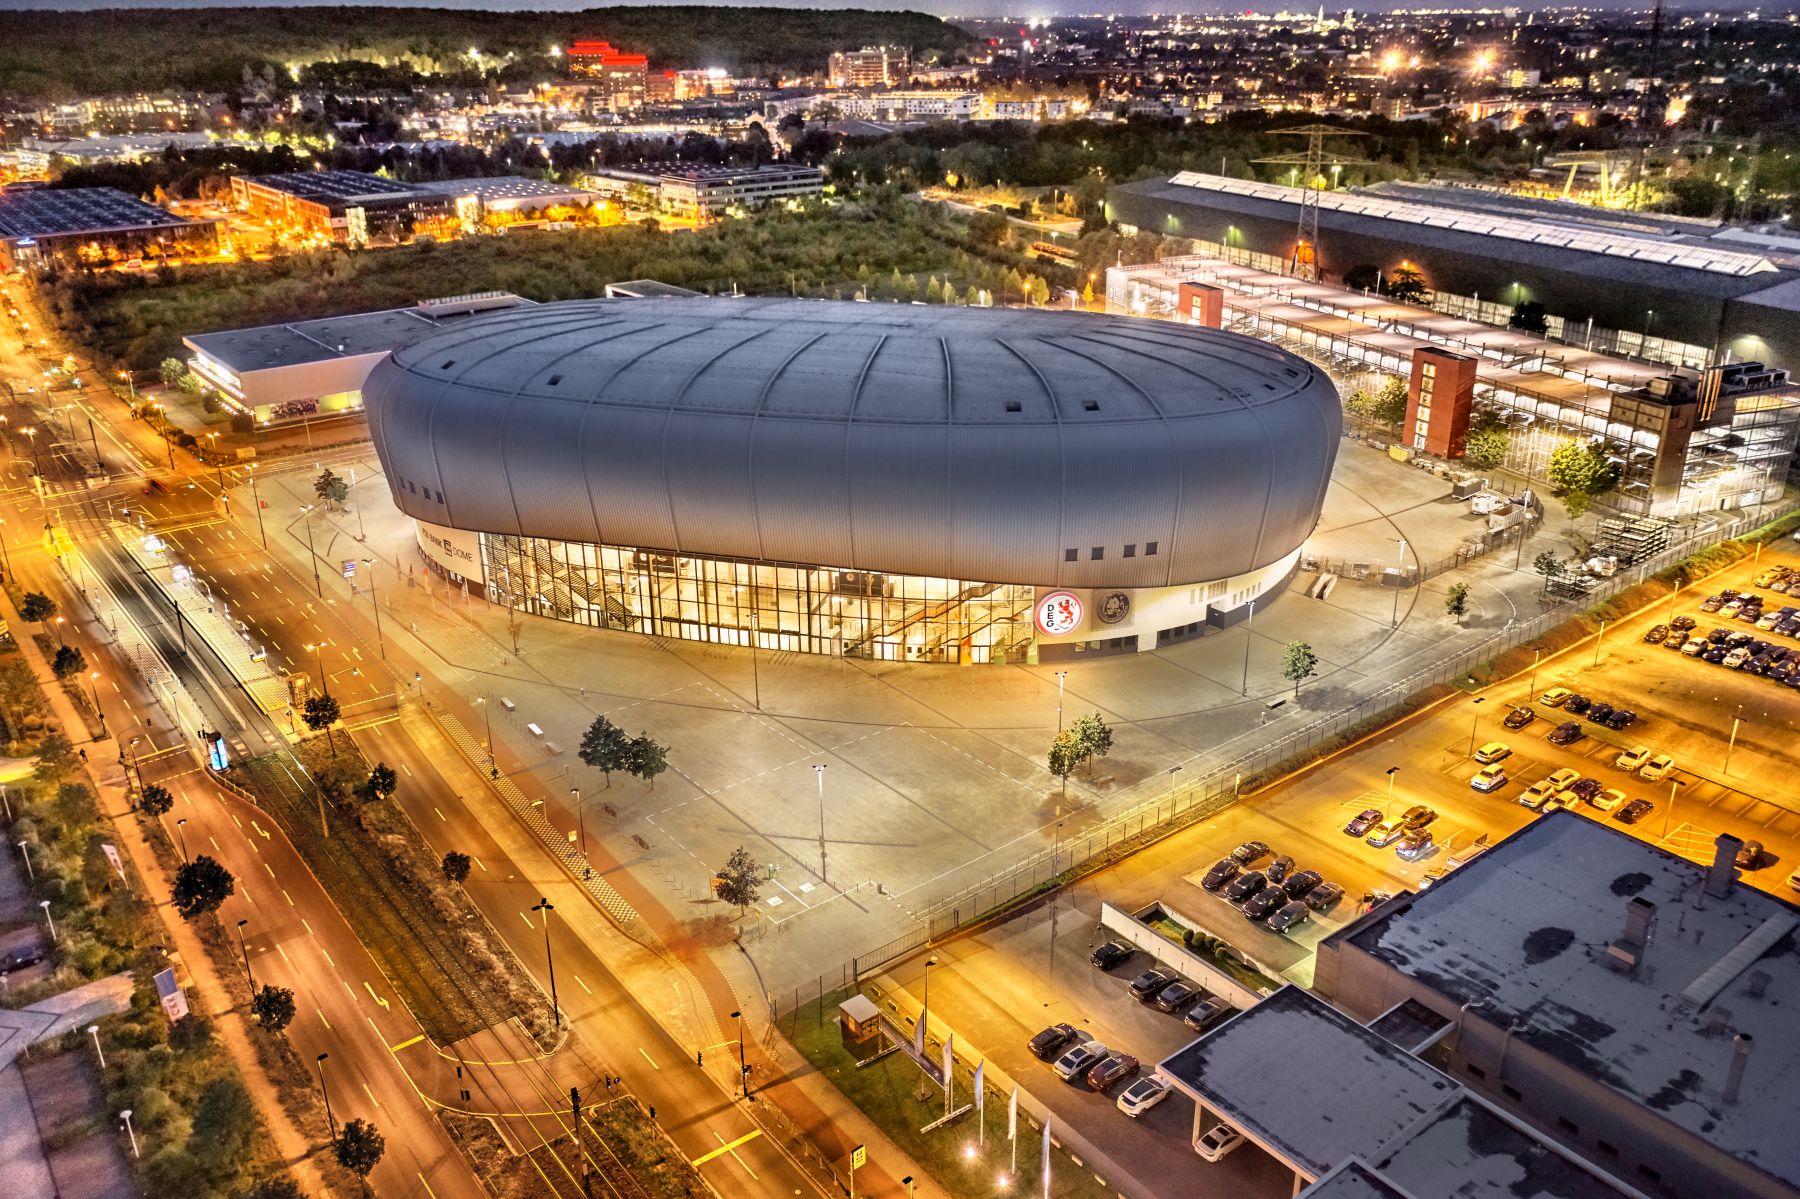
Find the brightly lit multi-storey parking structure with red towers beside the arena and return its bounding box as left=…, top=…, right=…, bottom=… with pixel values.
left=1107, top=254, right=1800, bottom=517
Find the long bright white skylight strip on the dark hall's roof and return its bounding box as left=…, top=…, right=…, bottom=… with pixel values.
left=1168, top=171, right=1778, bottom=277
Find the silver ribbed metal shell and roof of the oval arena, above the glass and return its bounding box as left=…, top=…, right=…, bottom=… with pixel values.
left=364, top=299, right=1341, bottom=587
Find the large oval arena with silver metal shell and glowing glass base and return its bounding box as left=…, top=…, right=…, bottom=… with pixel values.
left=364, top=299, right=1343, bottom=663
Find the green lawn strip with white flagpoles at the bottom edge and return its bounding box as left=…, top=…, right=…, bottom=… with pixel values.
left=781, top=992, right=1114, bottom=1199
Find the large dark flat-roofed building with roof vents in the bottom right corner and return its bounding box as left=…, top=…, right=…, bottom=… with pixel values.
left=1310, top=812, right=1800, bottom=1199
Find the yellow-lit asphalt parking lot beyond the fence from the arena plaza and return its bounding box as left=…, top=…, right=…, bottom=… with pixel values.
left=889, top=544, right=1800, bottom=1195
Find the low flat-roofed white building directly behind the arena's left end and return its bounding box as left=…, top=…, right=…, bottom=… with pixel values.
left=182, top=292, right=531, bottom=428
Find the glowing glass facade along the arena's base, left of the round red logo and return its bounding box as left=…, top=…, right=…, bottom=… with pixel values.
left=481, top=533, right=1033, bottom=663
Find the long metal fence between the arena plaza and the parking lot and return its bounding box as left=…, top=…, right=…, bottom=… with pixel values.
left=824, top=489, right=1800, bottom=1005
